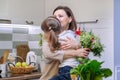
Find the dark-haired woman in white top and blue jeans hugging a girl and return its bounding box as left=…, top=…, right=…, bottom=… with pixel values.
left=50, top=6, right=82, bottom=80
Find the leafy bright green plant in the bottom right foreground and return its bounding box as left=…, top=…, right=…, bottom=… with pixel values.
left=70, top=59, right=112, bottom=80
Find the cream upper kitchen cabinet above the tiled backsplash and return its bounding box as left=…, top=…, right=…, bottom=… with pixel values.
left=0, top=0, right=45, bottom=25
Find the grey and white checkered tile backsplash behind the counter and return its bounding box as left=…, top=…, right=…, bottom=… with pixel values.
left=0, top=24, right=41, bottom=56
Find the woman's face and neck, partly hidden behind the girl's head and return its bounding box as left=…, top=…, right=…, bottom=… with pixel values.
left=54, top=9, right=71, bottom=30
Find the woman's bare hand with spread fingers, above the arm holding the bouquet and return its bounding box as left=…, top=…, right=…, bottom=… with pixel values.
left=60, top=37, right=80, bottom=50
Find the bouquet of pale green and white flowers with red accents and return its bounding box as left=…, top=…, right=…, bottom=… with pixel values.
left=76, top=31, right=104, bottom=57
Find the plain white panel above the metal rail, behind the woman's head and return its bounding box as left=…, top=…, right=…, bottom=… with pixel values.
left=45, top=0, right=113, bottom=21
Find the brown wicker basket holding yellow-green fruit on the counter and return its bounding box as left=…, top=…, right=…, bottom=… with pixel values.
left=8, top=57, right=35, bottom=74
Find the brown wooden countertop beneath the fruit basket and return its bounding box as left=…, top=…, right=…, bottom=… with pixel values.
left=0, top=72, right=41, bottom=80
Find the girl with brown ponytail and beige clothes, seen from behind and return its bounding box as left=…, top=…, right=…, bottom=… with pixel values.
left=40, top=16, right=63, bottom=80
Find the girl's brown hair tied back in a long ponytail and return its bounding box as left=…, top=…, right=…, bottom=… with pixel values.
left=41, top=16, right=61, bottom=52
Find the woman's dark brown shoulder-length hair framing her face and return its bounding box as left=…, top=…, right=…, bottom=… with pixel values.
left=53, top=6, right=77, bottom=31
